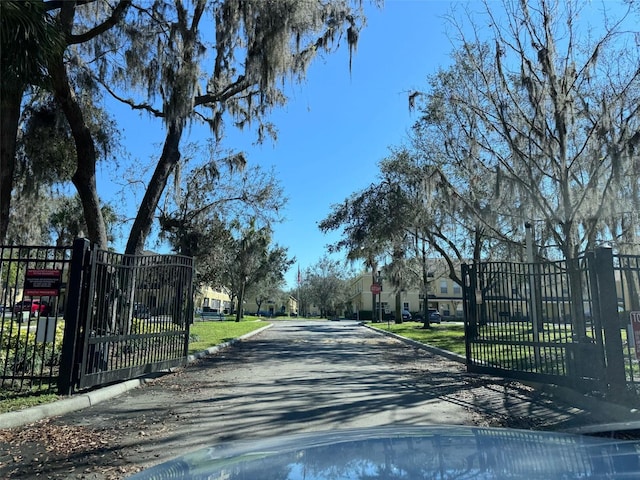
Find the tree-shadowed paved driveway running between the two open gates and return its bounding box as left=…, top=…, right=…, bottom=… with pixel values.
left=0, top=321, right=620, bottom=480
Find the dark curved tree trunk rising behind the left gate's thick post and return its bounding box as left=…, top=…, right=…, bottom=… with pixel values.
left=49, top=56, right=107, bottom=250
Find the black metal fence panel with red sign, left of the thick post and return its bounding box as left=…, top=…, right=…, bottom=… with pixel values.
left=0, top=246, right=71, bottom=391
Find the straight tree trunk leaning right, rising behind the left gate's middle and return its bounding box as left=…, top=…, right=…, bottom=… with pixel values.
left=125, top=123, right=183, bottom=255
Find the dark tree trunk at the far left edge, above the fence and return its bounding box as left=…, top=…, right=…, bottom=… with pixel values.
left=0, top=85, right=24, bottom=245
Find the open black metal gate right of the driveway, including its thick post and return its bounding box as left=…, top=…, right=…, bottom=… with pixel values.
left=462, top=248, right=628, bottom=391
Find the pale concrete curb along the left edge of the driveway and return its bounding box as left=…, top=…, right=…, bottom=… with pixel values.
left=0, top=324, right=273, bottom=429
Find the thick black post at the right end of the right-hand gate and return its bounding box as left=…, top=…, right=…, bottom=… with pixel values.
left=595, top=247, right=627, bottom=393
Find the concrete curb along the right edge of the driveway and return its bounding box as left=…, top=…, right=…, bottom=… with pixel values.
left=361, top=323, right=640, bottom=431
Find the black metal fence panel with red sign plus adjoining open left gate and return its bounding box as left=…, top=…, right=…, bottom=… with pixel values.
left=0, top=240, right=193, bottom=394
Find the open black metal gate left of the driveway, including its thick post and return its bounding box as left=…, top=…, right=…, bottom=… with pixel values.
left=59, top=240, right=194, bottom=394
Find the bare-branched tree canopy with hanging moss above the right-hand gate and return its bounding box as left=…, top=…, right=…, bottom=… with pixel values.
left=414, top=0, right=640, bottom=259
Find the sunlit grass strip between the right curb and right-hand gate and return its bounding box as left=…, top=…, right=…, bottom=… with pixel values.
left=374, top=322, right=465, bottom=355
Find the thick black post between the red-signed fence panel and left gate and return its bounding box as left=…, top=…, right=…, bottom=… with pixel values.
left=58, top=238, right=90, bottom=395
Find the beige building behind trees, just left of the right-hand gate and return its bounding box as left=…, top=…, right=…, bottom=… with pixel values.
left=350, top=273, right=463, bottom=319
